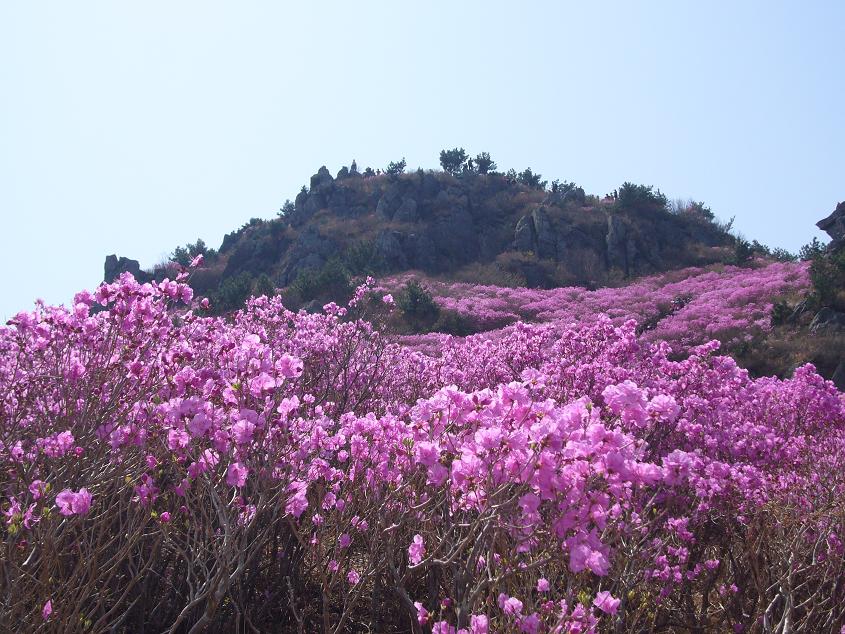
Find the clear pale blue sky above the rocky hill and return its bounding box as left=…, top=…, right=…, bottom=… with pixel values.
left=0, top=0, right=845, bottom=321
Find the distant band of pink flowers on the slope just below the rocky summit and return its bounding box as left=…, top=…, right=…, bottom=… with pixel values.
left=384, top=261, right=809, bottom=349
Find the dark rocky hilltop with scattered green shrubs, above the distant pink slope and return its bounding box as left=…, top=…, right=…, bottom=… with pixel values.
left=106, top=156, right=735, bottom=310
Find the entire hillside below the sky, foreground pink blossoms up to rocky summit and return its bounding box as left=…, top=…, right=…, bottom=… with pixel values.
left=9, top=164, right=845, bottom=634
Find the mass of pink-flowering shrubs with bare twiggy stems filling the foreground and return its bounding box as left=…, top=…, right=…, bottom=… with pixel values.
left=0, top=275, right=845, bottom=634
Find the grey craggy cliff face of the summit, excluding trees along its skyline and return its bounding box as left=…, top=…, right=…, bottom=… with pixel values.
left=213, top=167, right=731, bottom=286
